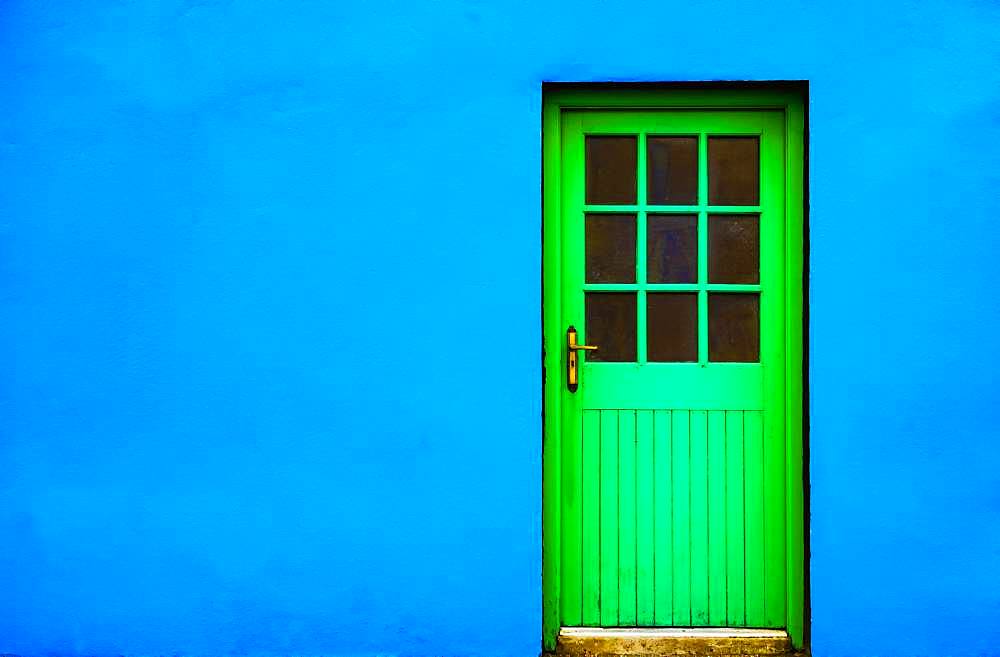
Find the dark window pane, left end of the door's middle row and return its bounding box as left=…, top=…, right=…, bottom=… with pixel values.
left=585, top=214, right=635, bottom=283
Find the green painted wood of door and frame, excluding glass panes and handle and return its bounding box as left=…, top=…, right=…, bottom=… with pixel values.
left=543, top=91, right=805, bottom=649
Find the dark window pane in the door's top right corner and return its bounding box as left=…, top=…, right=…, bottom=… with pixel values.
left=708, top=137, right=760, bottom=205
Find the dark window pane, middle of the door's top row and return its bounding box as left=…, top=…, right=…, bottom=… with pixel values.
left=646, top=137, right=698, bottom=205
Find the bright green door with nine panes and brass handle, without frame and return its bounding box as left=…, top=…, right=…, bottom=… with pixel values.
left=545, top=92, right=802, bottom=643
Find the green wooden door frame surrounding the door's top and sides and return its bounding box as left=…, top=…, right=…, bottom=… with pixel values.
left=542, top=85, right=808, bottom=651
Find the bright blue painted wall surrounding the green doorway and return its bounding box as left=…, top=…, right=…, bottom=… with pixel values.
left=0, top=0, right=1000, bottom=657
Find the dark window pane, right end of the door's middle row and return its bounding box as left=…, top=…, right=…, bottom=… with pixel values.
left=708, top=214, right=760, bottom=283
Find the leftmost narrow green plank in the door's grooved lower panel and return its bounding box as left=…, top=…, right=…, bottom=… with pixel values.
left=581, top=411, right=601, bottom=626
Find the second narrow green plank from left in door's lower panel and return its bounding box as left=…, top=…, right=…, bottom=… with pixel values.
left=601, top=411, right=618, bottom=627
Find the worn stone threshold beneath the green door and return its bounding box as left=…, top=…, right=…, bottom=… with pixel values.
left=556, top=627, right=796, bottom=657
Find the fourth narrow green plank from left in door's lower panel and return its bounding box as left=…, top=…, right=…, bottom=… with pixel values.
left=635, top=411, right=656, bottom=626
